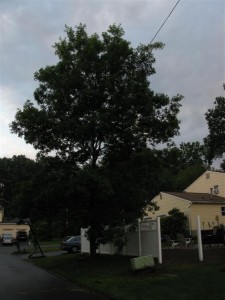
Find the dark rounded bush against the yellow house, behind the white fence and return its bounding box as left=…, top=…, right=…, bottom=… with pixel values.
left=161, top=208, right=188, bottom=239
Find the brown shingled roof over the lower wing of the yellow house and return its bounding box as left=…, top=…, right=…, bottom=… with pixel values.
left=164, top=192, right=225, bottom=204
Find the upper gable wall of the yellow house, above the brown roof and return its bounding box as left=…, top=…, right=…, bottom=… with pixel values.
left=185, top=171, right=225, bottom=197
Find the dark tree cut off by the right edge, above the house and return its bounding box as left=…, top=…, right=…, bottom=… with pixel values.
left=204, top=84, right=225, bottom=163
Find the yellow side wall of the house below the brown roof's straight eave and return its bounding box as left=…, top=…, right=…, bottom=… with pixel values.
left=190, top=204, right=225, bottom=230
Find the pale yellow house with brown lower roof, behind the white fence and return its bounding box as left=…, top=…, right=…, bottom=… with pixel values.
left=147, top=171, right=225, bottom=234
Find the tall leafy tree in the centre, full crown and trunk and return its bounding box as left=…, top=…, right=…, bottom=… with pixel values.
left=11, top=24, right=182, bottom=252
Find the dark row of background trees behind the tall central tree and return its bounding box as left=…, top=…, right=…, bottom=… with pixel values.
left=0, top=142, right=206, bottom=239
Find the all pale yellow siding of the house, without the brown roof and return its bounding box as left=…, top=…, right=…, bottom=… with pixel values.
left=147, top=171, right=225, bottom=233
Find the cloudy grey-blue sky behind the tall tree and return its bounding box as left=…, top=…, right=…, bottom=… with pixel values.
left=0, top=0, right=225, bottom=158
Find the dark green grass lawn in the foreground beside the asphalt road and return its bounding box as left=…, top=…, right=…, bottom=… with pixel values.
left=31, top=254, right=225, bottom=300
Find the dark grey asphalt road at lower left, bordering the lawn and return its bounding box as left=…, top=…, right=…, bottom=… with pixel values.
left=0, top=246, right=107, bottom=300
